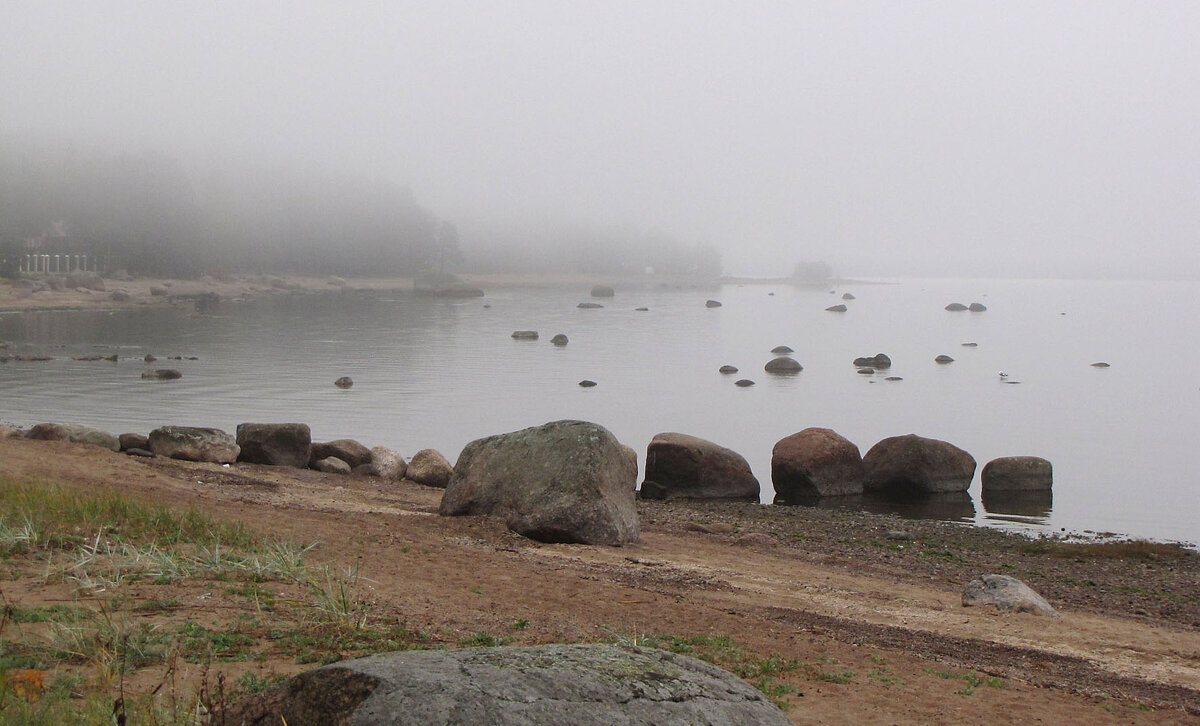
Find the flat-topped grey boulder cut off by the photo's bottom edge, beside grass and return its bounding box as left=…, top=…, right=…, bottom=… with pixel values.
left=219, top=644, right=791, bottom=726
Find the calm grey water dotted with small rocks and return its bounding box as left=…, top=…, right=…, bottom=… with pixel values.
left=0, top=280, right=1200, bottom=542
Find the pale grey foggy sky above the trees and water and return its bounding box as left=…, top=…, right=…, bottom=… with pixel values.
left=0, top=0, right=1200, bottom=276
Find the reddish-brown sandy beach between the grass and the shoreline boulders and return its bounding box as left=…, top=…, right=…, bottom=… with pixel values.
left=0, top=439, right=1200, bottom=724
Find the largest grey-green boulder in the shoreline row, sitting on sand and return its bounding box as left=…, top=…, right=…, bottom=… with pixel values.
left=438, top=421, right=640, bottom=545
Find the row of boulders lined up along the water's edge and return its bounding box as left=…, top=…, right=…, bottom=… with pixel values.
left=14, top=421, right=1052, bottom=545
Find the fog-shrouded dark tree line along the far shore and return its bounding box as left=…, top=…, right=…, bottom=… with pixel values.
left=0, top=137, right=721, bottom=277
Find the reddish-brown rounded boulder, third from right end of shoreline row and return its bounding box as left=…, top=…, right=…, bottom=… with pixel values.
left=770, top=427, right=863, bottom=504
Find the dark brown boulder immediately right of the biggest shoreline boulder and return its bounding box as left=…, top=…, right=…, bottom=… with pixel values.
left=642, top=433, right=758, bottom=502
